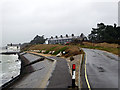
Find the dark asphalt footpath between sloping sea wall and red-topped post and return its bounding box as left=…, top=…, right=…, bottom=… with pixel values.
left=47, top=57, right=72, bottom=90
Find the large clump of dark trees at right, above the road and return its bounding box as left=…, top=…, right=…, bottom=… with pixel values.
left=88, top=23, right=120, bottom=43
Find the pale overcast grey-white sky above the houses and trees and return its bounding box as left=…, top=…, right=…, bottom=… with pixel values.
left=0, top=0, right=118, bottom=45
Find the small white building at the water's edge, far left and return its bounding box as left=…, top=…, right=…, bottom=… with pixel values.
left=6, top=43, right=20, bottom=52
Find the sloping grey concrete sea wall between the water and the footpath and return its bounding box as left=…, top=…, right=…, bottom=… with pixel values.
left=2, top=53, right=55, bottom=90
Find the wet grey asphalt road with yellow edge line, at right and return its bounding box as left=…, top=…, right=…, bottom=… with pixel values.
left=83, top=48, right=120, bottom=89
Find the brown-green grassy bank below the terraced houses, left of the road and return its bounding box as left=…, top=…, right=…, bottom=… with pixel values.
left=22, top=44, right=82, bottom=57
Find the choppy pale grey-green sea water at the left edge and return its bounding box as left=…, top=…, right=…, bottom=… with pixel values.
left=0, top=50, right=21, bottom=87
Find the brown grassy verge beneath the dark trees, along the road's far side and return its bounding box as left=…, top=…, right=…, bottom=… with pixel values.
left=80, top=42, right=120, bottom=55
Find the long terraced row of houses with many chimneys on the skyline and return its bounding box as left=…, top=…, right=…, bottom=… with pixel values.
left=46, top=34, right=87, bottom=44
